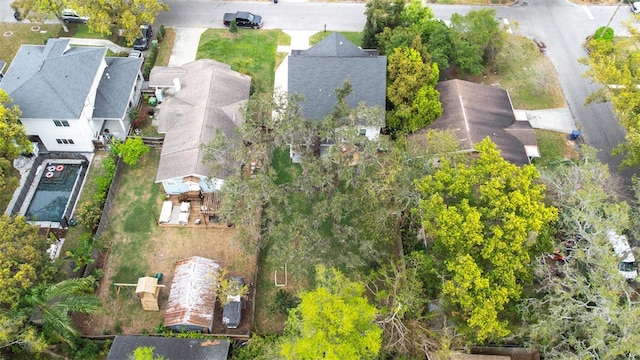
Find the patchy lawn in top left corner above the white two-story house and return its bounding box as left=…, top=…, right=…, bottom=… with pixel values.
left=0, top=23, right=62, bottom=71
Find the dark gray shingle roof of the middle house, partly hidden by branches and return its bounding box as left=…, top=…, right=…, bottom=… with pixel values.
left=288, top=32, right=387, bottom=119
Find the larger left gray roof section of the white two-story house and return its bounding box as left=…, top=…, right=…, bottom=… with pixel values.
left=0, top=39, right=107, bottom=119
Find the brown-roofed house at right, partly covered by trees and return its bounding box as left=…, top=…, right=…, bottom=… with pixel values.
left=426, top=79, right=540, bottom=165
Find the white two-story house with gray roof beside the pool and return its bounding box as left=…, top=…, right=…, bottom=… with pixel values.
left=0, top=39, right=143, bottom=152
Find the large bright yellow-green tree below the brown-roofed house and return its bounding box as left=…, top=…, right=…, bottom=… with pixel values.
left=418, top=138, right=557, bottom=342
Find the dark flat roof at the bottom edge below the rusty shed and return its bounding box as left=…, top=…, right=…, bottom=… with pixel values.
left=107, top=335, right=231, bottom=360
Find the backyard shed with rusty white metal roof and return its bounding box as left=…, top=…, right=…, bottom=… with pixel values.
left=164, top=256, right=220, bottom=333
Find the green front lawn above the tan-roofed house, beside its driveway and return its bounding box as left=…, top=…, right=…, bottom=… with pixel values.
left=196, top=29, right=281, bottom=92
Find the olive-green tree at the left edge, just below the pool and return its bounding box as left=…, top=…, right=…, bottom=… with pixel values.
left=0, top=215, right=57, bottom=309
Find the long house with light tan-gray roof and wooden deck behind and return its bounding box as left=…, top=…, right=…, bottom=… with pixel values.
left=149, top=59, right=251, bottom=194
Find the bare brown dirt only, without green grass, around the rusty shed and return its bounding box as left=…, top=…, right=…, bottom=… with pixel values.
left=79, top=228, right=255, bottom=335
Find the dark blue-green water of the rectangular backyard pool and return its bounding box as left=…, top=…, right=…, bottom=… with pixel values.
left=25, top=163, right=80, bottom=222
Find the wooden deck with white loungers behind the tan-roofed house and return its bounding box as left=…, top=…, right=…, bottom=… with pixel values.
left=159, top=192, right=229, bottom=227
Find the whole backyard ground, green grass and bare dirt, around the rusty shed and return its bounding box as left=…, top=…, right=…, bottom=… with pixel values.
left=77, top=149, right=256, bottom=335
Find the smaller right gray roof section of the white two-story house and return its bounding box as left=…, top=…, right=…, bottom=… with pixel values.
left=93, top=57, right=143, bottom=119
